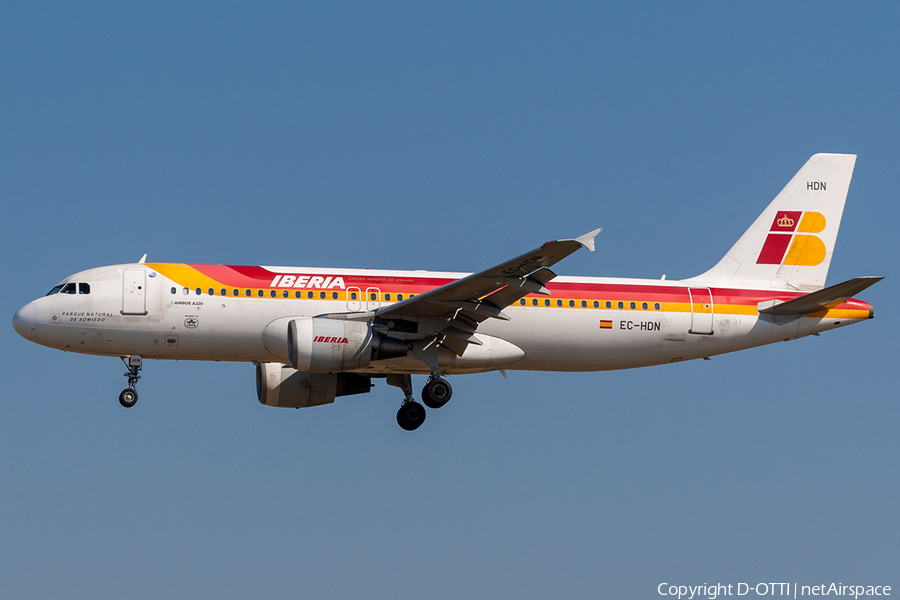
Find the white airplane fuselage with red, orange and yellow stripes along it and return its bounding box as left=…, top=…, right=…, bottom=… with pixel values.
left=14, top=264, right=871, bottom=374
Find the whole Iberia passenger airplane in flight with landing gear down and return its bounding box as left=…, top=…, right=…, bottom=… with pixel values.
left=13, top=154, right=882, bottom=431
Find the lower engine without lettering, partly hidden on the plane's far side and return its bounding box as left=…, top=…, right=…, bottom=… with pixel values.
left=256, top=363, right=372, bottom=408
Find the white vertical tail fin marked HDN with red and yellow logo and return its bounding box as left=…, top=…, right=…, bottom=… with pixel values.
left=687, top=154, right=856, bottom=291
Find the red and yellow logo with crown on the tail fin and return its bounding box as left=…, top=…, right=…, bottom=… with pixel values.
left=756, top=210, right=826, bottom=267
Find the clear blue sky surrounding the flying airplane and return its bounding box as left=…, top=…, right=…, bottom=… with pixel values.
left=0, top=2, right=900, bottom=599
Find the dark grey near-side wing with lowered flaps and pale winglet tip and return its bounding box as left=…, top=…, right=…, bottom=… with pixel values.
left=366, top=229, right=601, bottom=355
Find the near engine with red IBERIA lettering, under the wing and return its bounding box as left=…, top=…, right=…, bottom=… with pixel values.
left=282, top=317, right=409, bottom=373
